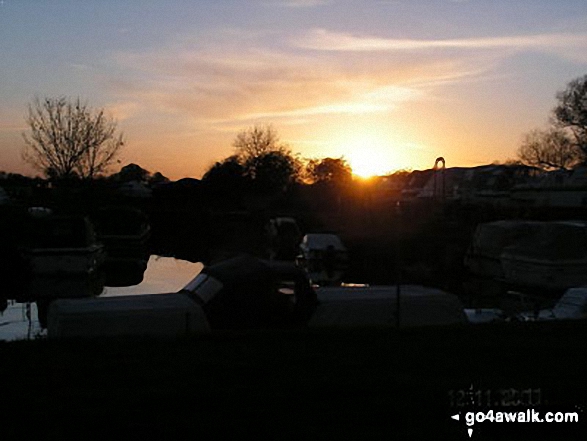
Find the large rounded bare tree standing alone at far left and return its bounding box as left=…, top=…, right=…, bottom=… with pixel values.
left=23, top=97, right=124, bottom=179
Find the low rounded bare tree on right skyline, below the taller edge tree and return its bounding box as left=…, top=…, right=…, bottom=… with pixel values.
left=518, top=128, right=583, bottom=170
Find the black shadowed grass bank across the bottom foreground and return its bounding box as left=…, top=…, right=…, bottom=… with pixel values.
left=0, top=322, right=587, bottom=440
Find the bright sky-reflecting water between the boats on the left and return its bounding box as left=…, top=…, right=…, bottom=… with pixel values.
left=0, top=256, right=204, bottom=341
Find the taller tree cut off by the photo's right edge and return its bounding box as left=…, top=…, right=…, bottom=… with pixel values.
left=553, top=75, right=587, bottom=158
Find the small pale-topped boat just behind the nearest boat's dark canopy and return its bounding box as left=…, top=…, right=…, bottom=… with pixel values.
left=297, top=233, right=349, bottom=285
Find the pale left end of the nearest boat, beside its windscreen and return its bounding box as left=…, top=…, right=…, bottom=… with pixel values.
left=47, top=294, right=210, bottom=338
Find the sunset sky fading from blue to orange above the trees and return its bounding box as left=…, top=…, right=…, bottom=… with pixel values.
left=0, top=0, right=587, bottom=179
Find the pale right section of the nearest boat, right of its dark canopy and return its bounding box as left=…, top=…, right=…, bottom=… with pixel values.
left=309, top=285, right=467, bottom=327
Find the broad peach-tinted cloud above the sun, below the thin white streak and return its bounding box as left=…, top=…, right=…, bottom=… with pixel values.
left=110, top=37, right=479, bottom=130
